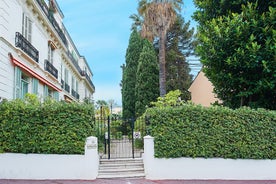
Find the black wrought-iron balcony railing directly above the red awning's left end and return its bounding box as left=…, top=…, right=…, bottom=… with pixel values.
left=15, top=32, right=39, bottom=63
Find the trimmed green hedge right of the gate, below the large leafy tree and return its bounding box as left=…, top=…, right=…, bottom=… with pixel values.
left=146, top=104, right=276, bottom=159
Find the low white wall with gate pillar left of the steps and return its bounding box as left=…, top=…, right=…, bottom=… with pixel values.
left=0, top=137, right=99, bottom=180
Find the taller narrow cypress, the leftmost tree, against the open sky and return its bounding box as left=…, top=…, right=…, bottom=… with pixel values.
left=122, top=30, right=143, bottom=119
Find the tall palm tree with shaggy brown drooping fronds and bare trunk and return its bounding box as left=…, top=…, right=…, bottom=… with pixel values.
left=138, top=0, right=183, bottom=97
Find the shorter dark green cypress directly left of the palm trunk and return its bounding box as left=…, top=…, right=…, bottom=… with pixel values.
left=135, top=40, right=159, bottom=117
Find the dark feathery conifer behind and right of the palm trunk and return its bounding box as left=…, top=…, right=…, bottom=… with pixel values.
left=163, top=15, right=195, bottom=100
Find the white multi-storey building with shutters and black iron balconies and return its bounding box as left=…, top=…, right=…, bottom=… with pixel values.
left=0, top=0, right=95, bottom=101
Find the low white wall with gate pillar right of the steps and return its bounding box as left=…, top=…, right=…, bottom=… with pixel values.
left=144, top=136, right=276, bottom=180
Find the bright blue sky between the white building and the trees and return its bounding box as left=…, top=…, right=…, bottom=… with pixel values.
left=57, top=0, right=195, bottom=105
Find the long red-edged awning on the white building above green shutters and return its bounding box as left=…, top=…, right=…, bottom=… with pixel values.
left=9, top=53, right=62, bottom=92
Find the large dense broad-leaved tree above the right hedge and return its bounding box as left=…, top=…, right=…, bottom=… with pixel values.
left=195, top=0, right=276, bottom=109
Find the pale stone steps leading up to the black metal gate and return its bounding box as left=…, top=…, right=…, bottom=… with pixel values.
left=97, top=158, right=145, bottom=179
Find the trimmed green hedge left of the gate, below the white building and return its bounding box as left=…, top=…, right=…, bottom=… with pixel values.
left=0, top=100, right=94, bottom=154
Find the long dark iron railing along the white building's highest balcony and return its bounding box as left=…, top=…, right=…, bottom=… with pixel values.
left=36, top=0, right=68, bottom=46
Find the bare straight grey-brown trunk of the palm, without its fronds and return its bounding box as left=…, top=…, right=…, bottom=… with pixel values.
left=159, top=30, right=166, bottom=97
